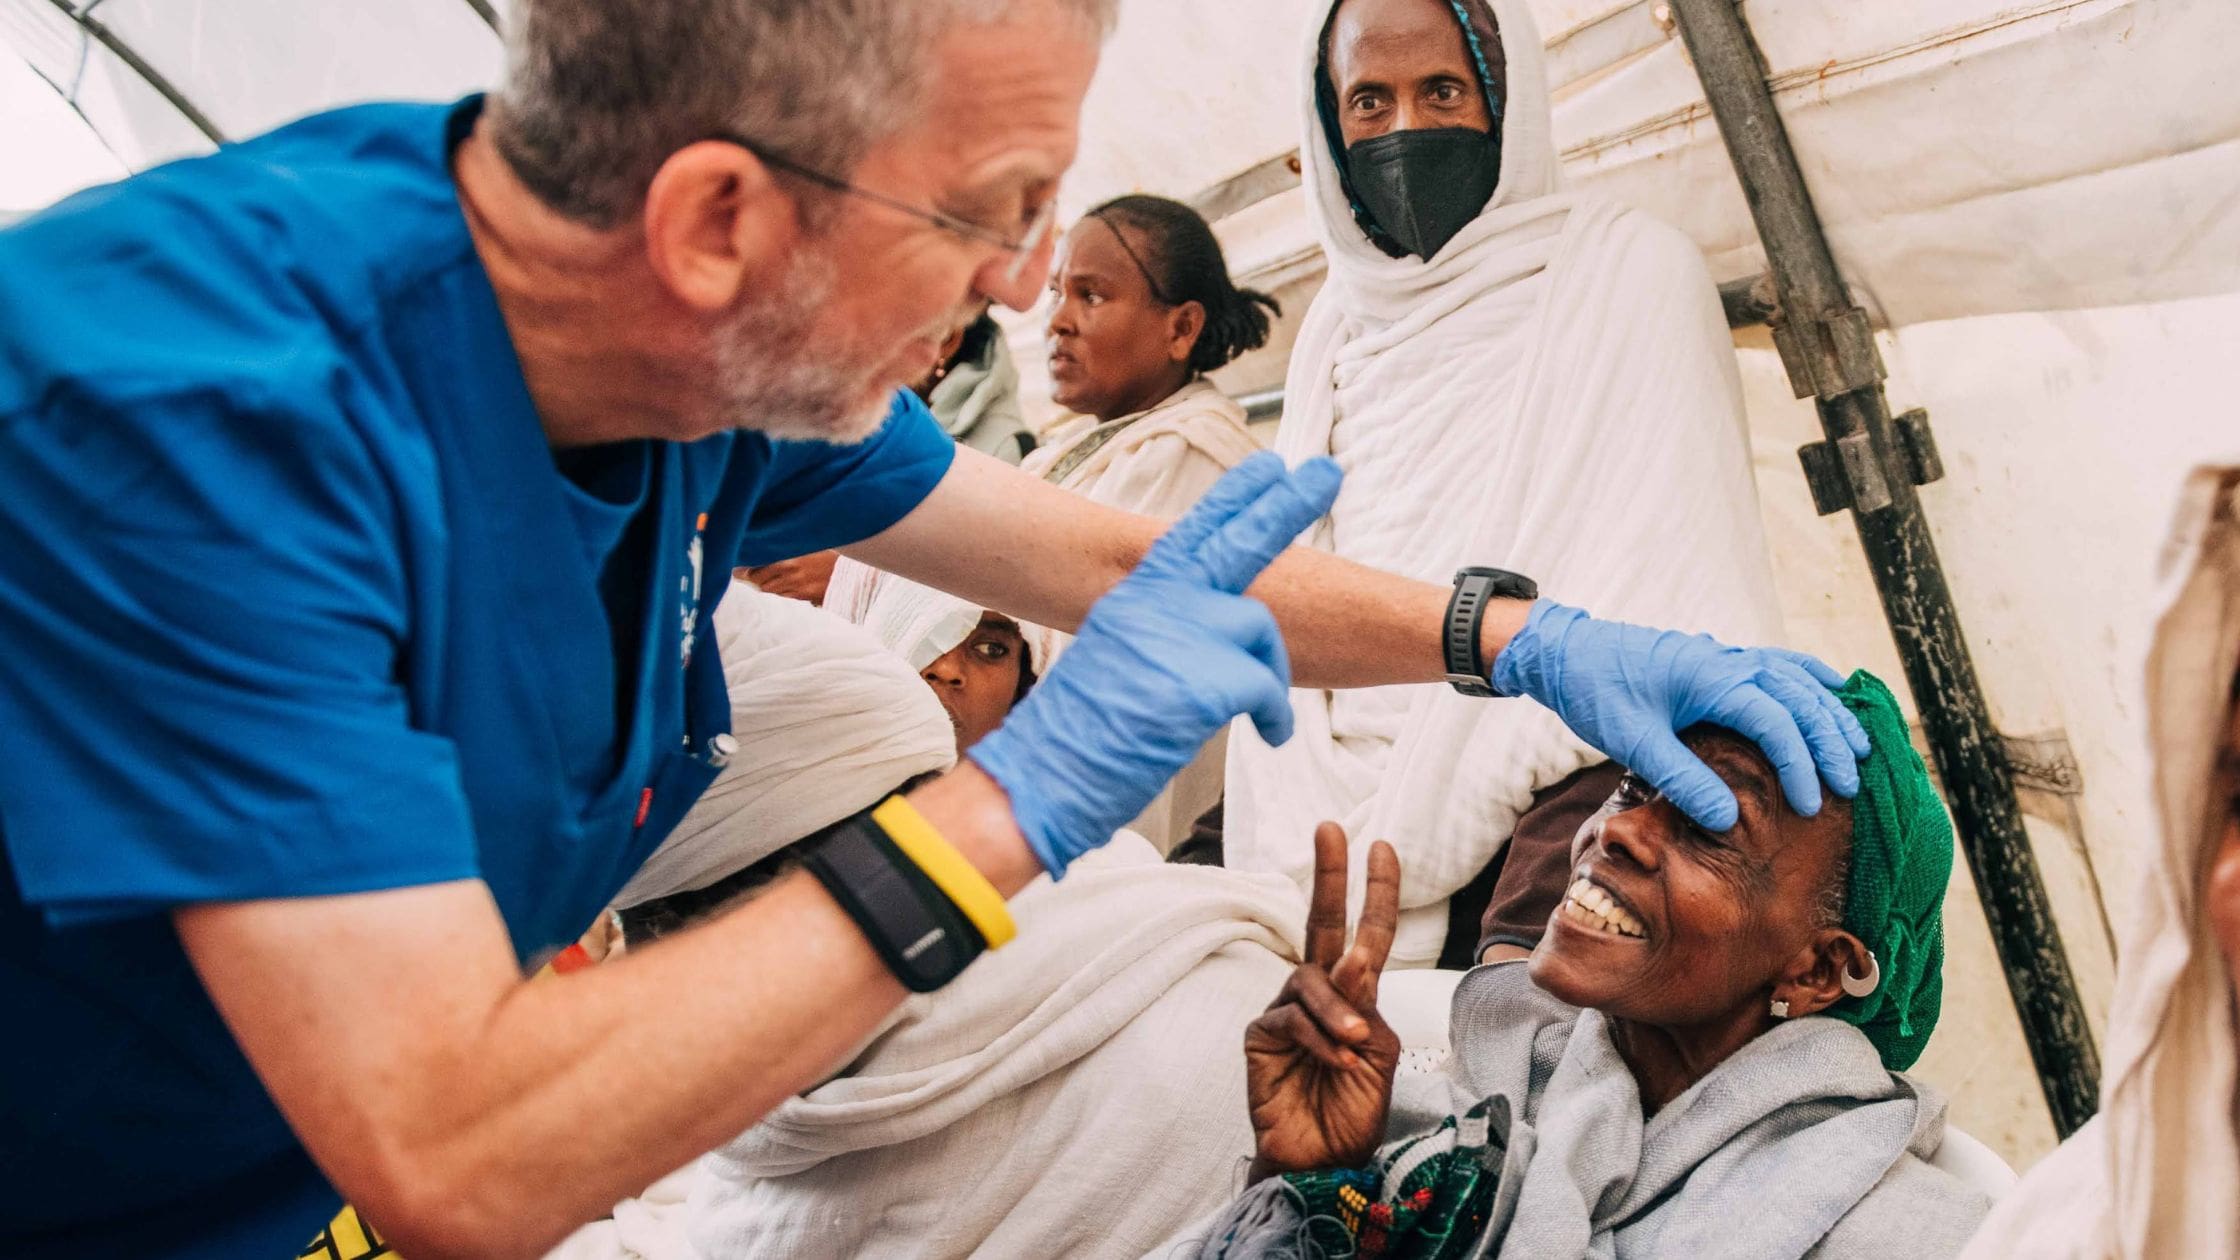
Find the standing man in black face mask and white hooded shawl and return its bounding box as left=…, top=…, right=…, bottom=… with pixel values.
left=1223, top=0, right=1783, bottom=966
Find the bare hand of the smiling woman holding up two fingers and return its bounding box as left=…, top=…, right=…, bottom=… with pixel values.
left=1245, top=823, right=1400, bottom=1182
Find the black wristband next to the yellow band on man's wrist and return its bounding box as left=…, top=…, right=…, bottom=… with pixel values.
left=802, top=809, right=983, bottom=993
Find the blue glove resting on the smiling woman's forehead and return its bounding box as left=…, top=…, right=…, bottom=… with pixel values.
left=1490, top=599, right=1870, bottom=832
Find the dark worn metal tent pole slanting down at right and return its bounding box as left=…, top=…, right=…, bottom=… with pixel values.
left=1671, top=0, right=2099, bottom=1137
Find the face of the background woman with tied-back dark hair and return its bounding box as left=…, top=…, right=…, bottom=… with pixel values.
left=1048, top=217, right=1192, bottom=419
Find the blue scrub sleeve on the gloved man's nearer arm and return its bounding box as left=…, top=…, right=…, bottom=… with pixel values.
left=0, top=383, right=477, bottom=926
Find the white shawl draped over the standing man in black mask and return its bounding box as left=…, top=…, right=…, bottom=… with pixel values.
left=1225, top=0, right=1781, bottom=966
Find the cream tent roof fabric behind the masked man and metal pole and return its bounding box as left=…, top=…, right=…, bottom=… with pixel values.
left=1068, top=0, right=2240, bottom=325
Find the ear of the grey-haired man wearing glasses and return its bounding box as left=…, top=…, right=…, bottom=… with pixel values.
left=643, top=139, right=802, bottom=314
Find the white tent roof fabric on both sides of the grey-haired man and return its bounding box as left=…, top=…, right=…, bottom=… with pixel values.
left=0, top=0, right=2240, bottom=323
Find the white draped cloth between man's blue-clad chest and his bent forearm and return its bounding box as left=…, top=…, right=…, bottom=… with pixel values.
left=614, top=583, right=956, bottom=906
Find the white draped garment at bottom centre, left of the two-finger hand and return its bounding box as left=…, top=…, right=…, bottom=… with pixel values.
left=680, top=832, right=1306, bottom=1260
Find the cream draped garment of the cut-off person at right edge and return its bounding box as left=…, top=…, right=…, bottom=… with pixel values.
left=1964, top=460, right=2240, bottom=1260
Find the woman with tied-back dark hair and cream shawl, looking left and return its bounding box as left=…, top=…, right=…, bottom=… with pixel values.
left=824, top=195, right=1281, bottom=852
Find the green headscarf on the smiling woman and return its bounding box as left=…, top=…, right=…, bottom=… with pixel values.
left=1828, top=670, right=1953, bottom=1072
